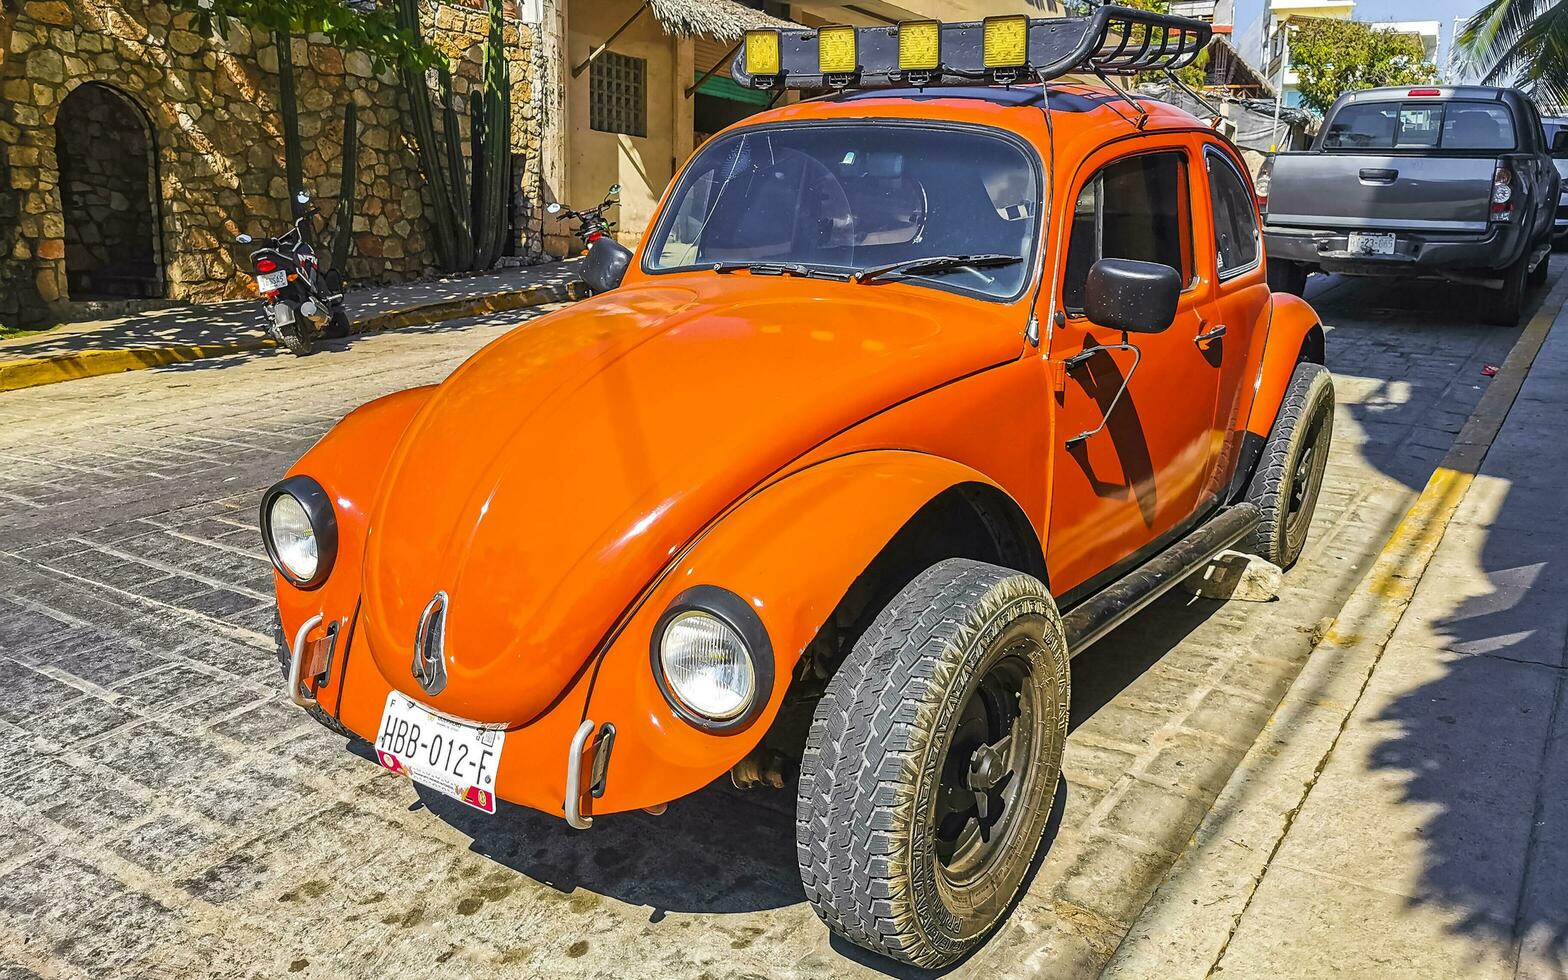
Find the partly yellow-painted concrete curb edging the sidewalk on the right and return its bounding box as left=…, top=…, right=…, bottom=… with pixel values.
left=1101, top=274, right=1568, bottom=977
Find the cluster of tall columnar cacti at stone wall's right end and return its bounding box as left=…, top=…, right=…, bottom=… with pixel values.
left=397, top=0, right=511, bottom=271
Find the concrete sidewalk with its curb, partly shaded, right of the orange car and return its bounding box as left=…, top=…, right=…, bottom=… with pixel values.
left=1104, top=285, right=1568, bottom=978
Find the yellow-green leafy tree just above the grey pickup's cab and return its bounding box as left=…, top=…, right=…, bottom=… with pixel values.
left=1289, top=17, right=1438, bottom=113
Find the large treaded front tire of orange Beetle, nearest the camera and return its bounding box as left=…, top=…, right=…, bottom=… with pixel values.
left=795, top=558, right=1069, bottom=967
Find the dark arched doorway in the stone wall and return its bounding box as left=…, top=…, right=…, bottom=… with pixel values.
left=55, top=82, right=163, bottom=299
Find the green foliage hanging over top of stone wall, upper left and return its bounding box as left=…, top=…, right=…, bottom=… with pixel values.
left=169, top=0, right=442, bottom=71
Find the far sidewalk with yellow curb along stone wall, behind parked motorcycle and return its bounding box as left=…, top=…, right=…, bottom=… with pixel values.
left=0, top=260, right=582, bottom=392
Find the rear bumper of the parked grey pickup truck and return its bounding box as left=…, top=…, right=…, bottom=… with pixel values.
left=1264, top=218, right=1530, bottom=278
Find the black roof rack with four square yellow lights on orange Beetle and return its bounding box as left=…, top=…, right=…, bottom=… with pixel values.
left=731, top=6, right=1214, bottom=89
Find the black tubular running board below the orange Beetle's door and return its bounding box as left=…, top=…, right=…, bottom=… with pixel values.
left=1062, top=503, right=1262, bottom=657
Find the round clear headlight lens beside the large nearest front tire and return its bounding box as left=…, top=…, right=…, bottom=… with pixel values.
left=659, top=610, right=757, bottom=721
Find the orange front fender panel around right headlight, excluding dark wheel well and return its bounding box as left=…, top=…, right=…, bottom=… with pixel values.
left=585, top=450, right=1038, bottom=812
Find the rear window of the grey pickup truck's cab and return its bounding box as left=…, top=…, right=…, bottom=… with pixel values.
left=1323, top=100, right=1516, bottom=151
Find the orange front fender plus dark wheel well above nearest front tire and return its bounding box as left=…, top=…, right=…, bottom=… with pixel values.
left=586, top=450, right=1044, bottom=812
